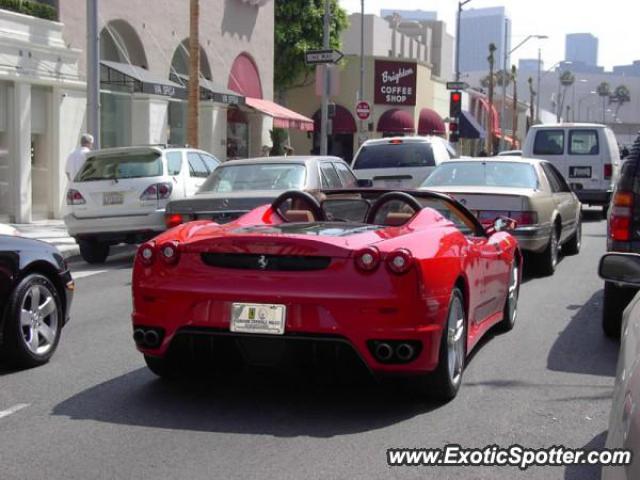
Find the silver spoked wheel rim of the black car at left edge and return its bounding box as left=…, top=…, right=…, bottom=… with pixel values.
left=20, top=285, right=58, bottom=355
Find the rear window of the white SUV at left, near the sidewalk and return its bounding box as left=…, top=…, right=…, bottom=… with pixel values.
left=75, top=152, right=164, bottom=182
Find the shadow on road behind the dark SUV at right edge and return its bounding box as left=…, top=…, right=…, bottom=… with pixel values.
left=547, top=290, right=619, bottom=377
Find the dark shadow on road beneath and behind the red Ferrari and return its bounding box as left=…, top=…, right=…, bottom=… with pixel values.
left=53, top=368, right=439, bottom=438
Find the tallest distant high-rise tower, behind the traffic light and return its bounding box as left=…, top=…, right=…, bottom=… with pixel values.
left=460, top=7, right=511, bottom=73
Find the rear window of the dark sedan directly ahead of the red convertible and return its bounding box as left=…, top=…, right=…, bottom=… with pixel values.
left=198, top=163, right=306, bottom=193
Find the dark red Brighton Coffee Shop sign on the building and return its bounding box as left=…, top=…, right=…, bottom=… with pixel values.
left=375, top=60, right=418, bottom=106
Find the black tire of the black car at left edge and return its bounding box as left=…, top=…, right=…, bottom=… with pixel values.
left=2, top=273, right=64, bottom=368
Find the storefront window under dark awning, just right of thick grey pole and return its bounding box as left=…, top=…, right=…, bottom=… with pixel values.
left=100, top=92, right=131, bottom=148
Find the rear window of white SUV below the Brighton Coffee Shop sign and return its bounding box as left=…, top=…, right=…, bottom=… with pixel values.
left=353, top=143, right=436, bottom=170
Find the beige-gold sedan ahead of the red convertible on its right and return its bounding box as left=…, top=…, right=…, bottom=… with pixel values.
left=421, top=157, right=582, bottom=275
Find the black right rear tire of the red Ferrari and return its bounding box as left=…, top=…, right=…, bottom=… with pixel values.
left=415, top=287, right=467, bottom=401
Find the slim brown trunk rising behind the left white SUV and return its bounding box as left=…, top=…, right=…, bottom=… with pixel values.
left=187, top=0, right=200, bottom=148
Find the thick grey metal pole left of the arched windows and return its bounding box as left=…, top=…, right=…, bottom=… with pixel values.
left=87, top=0, right=100, bottom=149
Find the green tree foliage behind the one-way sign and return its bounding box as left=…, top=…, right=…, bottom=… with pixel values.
left=274, top=0, right=348, bottom=96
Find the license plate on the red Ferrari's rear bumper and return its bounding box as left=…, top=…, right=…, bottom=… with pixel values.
left=230, top=303, right=287, bottom=335
